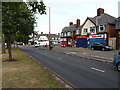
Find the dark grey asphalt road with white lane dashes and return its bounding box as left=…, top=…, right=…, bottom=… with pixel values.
left=20, top=46, right=119, bottom=88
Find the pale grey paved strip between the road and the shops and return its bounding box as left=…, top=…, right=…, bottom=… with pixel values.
left=38, top=46, right=117, bottom=63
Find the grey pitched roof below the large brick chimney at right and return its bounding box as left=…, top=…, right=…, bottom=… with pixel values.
left=89, top=13, right=116, bottom=25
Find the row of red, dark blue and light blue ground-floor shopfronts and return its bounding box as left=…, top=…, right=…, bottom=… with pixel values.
left=61, top=33, right=108, bottom=48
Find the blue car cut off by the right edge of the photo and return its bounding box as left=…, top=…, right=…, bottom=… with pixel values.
left=113, top=50, right=120, bottom=71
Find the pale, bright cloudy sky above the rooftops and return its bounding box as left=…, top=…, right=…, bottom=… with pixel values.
left=31, top=0, right=120, bottom=34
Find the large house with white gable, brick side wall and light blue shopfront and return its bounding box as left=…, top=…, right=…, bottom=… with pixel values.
left=81, top=8, right=117, bottom=49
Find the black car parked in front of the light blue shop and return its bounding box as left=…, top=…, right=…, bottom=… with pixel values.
left=91, top=43, right=112, bottom=51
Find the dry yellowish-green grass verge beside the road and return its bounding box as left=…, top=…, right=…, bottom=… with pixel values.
left=2, top=48, right=62, bottom=88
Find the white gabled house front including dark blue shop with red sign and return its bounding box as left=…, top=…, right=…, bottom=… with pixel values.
left=76, top=17, right=96, bottom=48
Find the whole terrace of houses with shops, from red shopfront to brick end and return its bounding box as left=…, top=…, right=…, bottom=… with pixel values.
left=61, top=8, right=120, bottom=49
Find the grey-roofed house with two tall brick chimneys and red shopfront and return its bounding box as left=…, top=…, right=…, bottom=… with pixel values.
left=61, top=19, right=80, bottom=47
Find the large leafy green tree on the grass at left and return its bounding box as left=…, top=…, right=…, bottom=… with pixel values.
left=2, top=2, right=45, bottom=61
